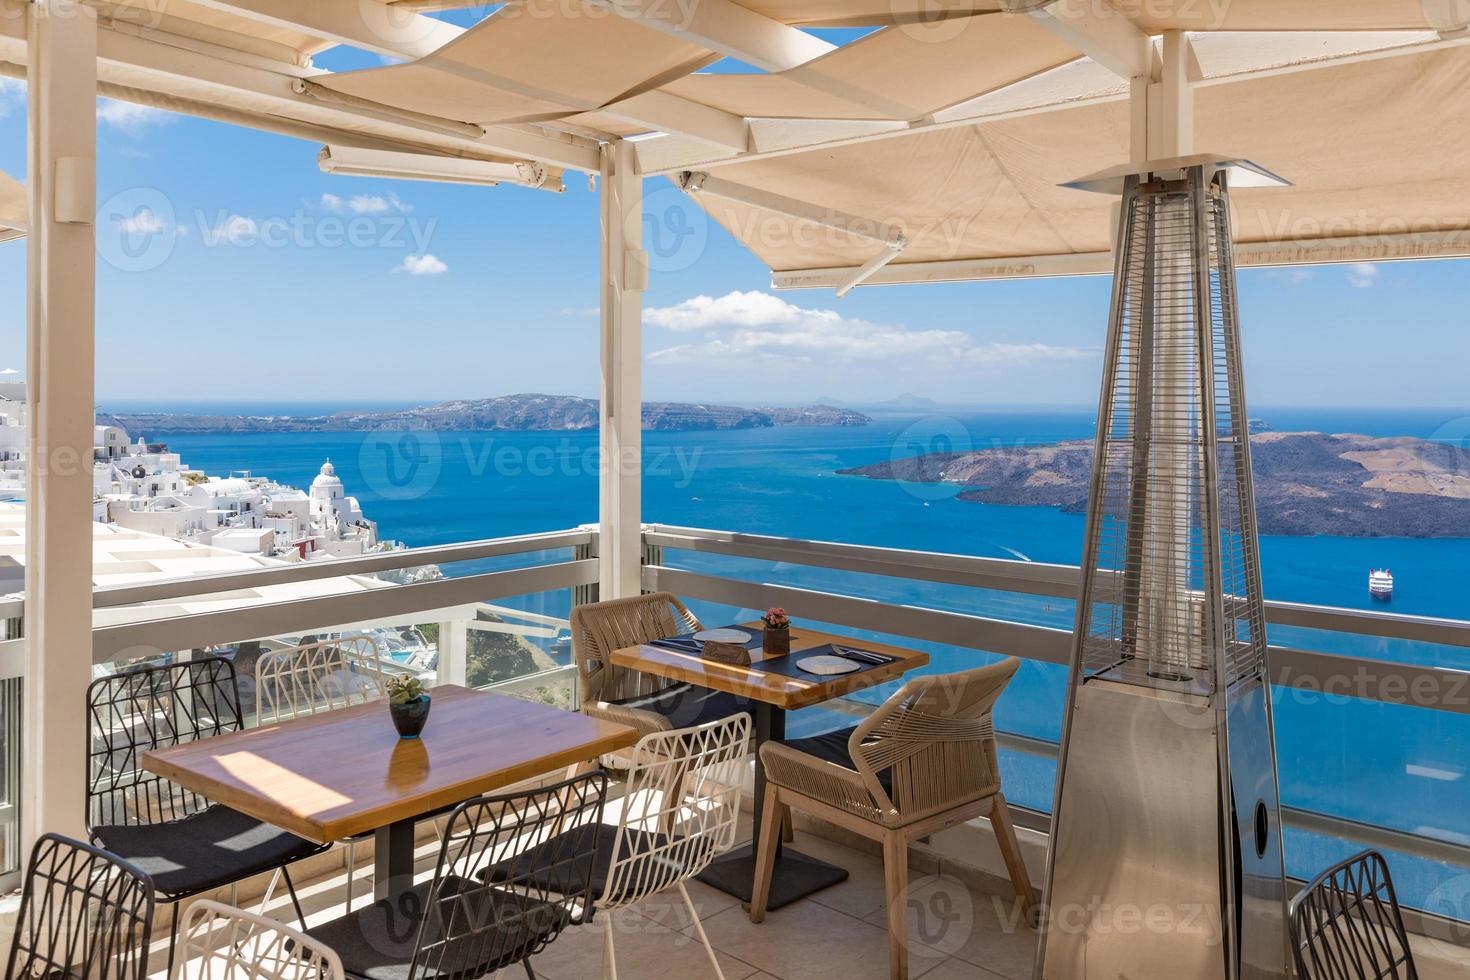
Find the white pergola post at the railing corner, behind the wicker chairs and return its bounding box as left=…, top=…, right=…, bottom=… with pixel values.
left=598, top=140, right=648, bottom=599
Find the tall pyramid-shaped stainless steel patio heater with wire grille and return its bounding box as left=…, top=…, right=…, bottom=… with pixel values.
left=1036, top=156, right=1288, bottom=980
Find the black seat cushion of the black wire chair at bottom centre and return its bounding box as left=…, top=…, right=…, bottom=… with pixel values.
left=306, top=876, right=570, bottom=980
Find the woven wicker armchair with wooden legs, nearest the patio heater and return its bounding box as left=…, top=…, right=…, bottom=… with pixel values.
left=750, top=657, right=1036, bottom=980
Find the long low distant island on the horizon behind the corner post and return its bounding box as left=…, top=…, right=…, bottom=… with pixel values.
left=97, top=394, right=870, bottom=438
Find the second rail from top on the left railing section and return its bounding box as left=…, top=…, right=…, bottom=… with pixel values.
left=93, top=558, right=597, bottom=663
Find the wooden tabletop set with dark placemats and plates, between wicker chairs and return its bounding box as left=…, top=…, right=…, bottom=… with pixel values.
left=612, top=621, right=929, bottom=708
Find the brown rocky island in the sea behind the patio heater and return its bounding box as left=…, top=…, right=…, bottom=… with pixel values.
left=841, top=432, right=1470, bottom=538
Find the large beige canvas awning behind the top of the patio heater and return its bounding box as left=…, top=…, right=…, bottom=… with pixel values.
left=682, top=47, right=1470, bottom=272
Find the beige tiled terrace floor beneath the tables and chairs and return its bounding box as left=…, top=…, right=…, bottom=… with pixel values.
left=159, top=811, right=1036, bottom=980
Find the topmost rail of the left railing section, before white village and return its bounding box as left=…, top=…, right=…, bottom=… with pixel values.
left=93, top=529, right=595, bottom=608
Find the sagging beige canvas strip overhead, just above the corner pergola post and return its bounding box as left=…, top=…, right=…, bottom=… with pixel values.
left=316, top=0, right=716, bottom=123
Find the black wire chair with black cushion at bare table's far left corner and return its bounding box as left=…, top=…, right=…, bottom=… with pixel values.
left=87, top=657, right=329, bottom=970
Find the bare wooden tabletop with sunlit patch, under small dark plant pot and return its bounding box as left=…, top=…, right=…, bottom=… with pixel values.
left=143, top=686, right=638, bottom=843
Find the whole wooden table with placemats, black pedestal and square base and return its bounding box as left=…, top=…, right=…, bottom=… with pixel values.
left=612, top=621, right=929, bottom=908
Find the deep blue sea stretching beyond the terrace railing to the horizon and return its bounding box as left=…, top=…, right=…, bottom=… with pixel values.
left=152, top=406, right=1470, bottom=918
